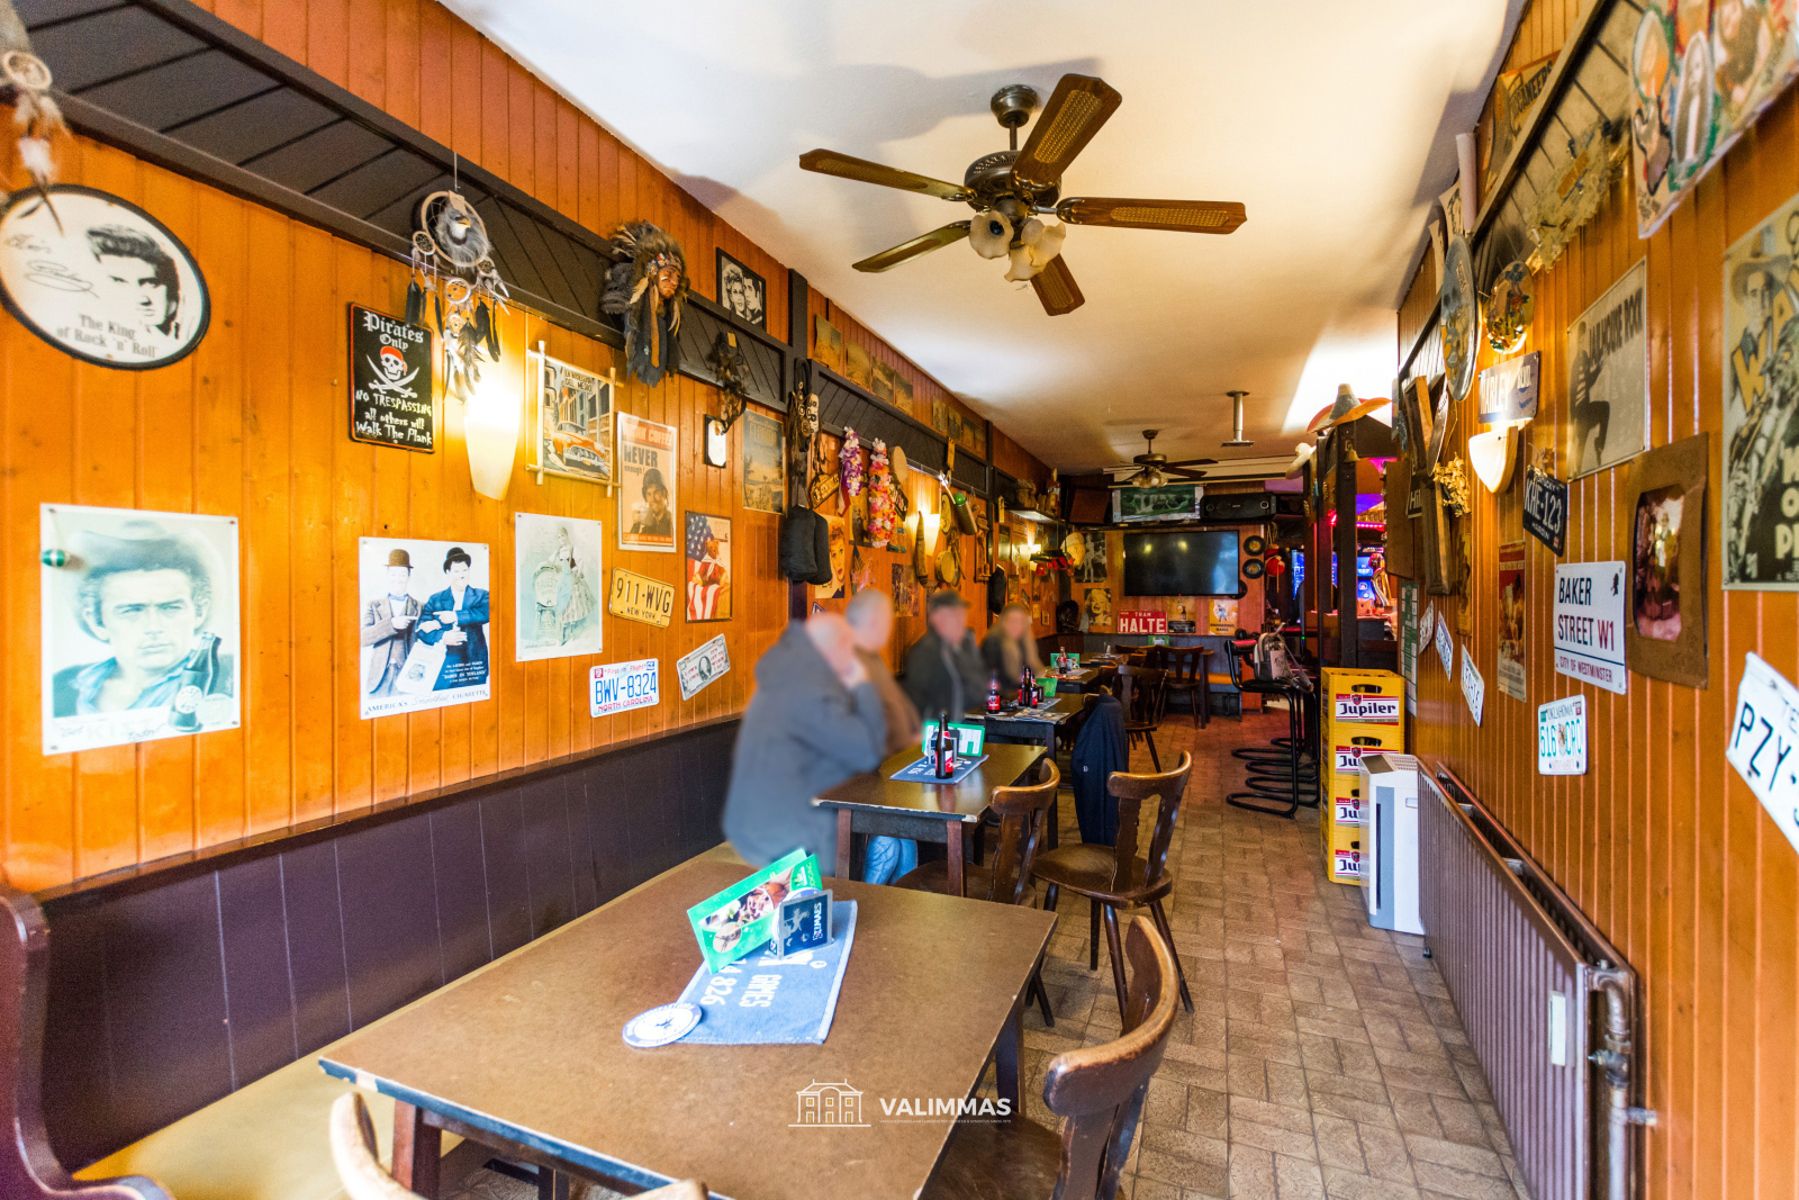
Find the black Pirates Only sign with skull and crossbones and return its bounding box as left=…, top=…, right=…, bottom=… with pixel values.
left=349, top=304, right=437, bottom=453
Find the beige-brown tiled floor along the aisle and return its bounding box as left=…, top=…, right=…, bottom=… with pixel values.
left=446, top=716, right=1526, bottom=1200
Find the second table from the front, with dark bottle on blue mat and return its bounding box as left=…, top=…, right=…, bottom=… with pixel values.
left=811, top=745, right=1043, bottom=896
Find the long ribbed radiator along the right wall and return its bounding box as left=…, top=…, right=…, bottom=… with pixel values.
left=1418, top=768, right=1655, bottom=1200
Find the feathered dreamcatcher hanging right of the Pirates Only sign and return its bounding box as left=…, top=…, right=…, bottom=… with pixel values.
left=407, top=191, right=511, bottom=398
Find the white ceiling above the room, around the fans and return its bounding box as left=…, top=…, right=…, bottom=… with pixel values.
left=446, top=0, right=1524, bottom=470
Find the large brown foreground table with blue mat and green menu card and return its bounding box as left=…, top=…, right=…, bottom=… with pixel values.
left=320, top=860, right=1054, bottom=1200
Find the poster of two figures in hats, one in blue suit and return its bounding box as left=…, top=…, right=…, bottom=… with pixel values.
left=356, top=538, right=493, bottom=720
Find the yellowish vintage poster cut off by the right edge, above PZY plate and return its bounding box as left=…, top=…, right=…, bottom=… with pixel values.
left=1720, top=196, right=1799, bottom=590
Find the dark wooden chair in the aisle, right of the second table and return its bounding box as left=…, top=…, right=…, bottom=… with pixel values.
left=1034, top=752, right=1193, bottom=1013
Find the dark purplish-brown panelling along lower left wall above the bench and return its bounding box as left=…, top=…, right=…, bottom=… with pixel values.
left=29, top=720, right=738, bottom=1168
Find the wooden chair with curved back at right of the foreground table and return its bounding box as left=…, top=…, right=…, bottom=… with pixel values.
left=919, top=918, right=1178, bottom=1200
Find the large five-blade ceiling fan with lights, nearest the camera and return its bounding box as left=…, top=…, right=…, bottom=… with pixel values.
left=799, top=76, right=1247, bottom=317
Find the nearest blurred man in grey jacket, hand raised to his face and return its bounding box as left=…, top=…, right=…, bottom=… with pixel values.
left=725, top=613, right=887, bottom=871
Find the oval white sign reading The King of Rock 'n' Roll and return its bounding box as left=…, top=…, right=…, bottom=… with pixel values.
left=0, top=184, right=212, bottom=371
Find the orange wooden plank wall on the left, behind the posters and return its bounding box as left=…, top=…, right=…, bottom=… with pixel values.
left=0, top=0, right=1050, bottom=889
